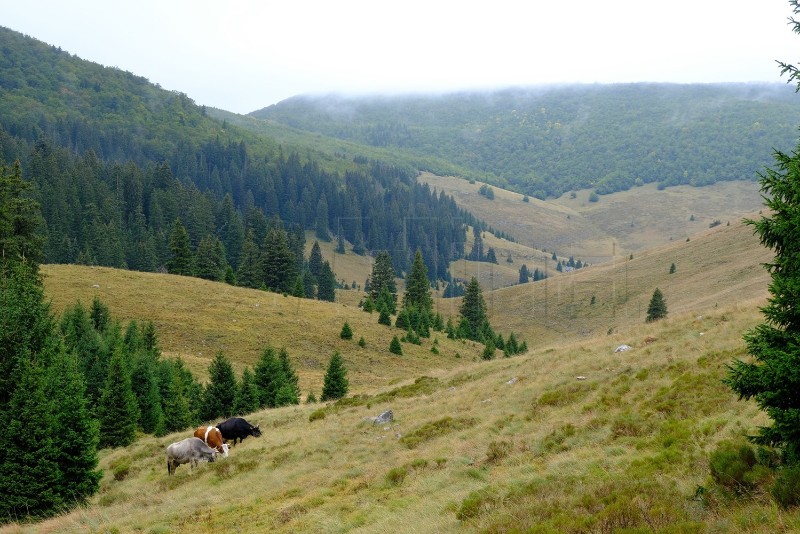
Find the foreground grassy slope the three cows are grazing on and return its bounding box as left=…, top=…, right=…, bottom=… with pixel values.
left=15, top=301, right=800, bottom=533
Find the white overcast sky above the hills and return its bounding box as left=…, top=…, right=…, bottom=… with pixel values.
left=0, top=0, right=800, bottom=113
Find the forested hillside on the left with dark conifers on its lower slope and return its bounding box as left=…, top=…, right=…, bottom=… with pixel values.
left=0, top=27, right=474, bottom=284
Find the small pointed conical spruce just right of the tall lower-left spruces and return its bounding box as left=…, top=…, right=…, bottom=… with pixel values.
left=97, top=347, right=139, bottom=447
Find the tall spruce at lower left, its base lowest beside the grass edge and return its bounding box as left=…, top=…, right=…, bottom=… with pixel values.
left=45, top=344, right=102, bottom=504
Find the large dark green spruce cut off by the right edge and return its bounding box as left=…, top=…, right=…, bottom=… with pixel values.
left=726, top=37, right=800, bottom=465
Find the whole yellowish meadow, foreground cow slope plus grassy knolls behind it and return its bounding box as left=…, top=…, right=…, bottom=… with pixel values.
left=4, top=198, right=800, bottom=533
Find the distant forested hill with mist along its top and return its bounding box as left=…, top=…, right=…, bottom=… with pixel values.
left=250, top=83, right=800, bottom=198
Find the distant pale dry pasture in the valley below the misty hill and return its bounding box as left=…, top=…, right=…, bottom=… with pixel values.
left=419, top=173, right=762, bottom=264
